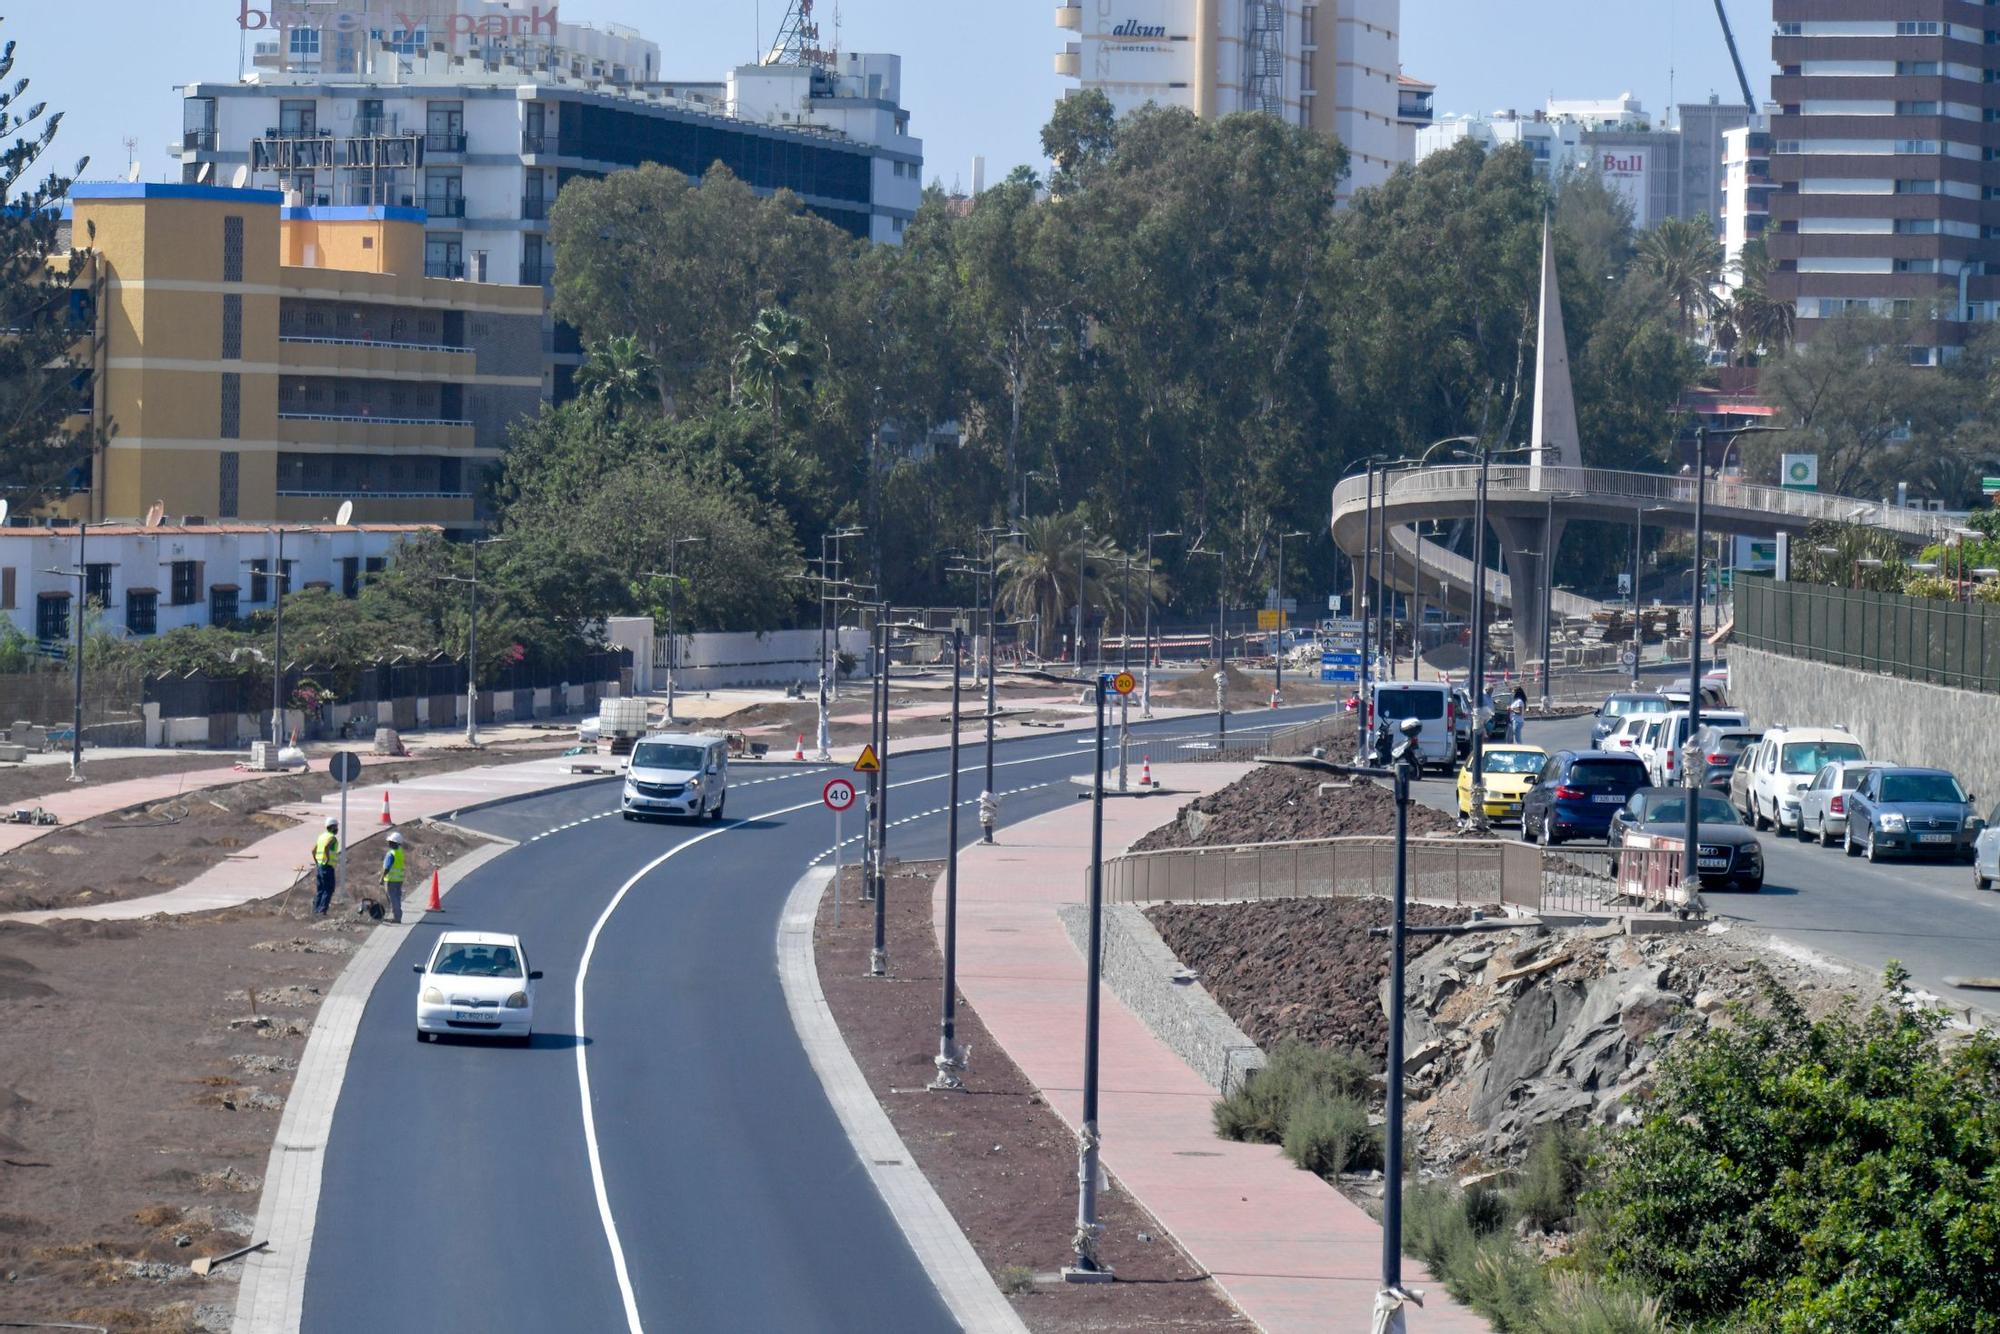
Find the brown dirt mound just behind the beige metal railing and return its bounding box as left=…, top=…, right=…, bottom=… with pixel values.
left=1132, top=764, right=1458, bottom=852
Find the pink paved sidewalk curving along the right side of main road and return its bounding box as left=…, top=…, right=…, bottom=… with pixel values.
left=936, top=764, right=1490, bottom=1334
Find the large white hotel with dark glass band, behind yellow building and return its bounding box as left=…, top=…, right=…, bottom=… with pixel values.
left=176, top=0, right=924, bottom=398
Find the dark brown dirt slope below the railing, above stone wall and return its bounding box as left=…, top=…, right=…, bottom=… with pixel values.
left=1146, top=898, right=1472, bottom=1060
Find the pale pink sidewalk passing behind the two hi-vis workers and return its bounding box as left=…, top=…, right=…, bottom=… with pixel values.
left=0, top=758, right=604, bottom=922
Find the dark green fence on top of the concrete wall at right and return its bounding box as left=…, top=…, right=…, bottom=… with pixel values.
left=1732, top=578, right=2000, bottom=694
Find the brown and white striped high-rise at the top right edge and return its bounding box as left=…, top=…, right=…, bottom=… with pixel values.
left=1766, top=0, right=2000, bottom=366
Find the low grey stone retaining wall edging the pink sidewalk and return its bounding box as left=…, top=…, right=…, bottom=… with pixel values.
left=1056, top=904, right=1264, bottom=1094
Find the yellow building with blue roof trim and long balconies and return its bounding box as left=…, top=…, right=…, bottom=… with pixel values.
left=66, top=184, right=542, bottom=528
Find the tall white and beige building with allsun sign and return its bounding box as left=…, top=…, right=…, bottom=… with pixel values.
left=1056, top=0, right=1408, bottom=190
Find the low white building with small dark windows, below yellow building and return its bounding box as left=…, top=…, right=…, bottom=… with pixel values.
left=0, top=524, right=438, bottom=644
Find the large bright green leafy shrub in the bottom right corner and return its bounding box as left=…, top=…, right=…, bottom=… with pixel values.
left=1594, top=964, right=2000, bottom=1334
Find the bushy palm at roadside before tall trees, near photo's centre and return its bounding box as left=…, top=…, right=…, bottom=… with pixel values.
left=996, top=510, right=1168, bottom=656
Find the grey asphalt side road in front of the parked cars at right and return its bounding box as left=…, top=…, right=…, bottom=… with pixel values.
left=1418, top=716, right=2000, bottom=1012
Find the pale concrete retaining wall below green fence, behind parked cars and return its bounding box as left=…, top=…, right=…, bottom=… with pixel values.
left=1728, top=646, right=2000, bottom=808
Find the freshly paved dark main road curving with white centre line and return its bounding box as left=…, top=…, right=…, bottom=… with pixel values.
left=302, top=706, right=1324, bottom=1334
